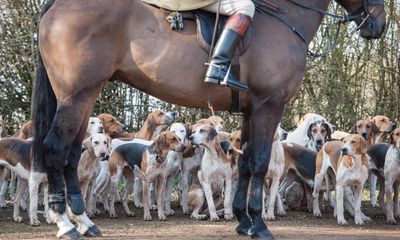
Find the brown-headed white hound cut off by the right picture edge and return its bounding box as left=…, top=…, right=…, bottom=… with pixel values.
left=384, top=128, right=400, bottom=224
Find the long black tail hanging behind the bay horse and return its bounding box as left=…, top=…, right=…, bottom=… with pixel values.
left=31, top=0, right=57, bottom=172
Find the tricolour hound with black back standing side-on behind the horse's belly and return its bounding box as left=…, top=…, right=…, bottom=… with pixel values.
left=109, top=131, right=185, bottom=220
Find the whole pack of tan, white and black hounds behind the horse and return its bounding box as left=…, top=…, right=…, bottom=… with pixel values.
left=0, top=110, right=400, bottom=225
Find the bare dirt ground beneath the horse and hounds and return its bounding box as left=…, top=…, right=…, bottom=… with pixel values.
left=0, top=202, right=400, bottom=240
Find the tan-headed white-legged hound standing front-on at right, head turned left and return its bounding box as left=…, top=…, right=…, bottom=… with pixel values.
left=334, top=134, right=371, bottom=225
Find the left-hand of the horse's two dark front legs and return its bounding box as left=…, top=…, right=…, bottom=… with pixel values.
left=233, top=116, right=252, bottom=236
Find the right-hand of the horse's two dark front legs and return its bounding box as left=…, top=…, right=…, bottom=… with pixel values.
left=248, top=102, right=284, bottom=239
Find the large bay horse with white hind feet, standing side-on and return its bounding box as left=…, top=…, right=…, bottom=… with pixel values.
left=32, top=0, right=385, bottom=239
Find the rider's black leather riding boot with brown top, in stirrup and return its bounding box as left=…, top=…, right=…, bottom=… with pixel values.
left=204, top=14, right=251, bottom=91
